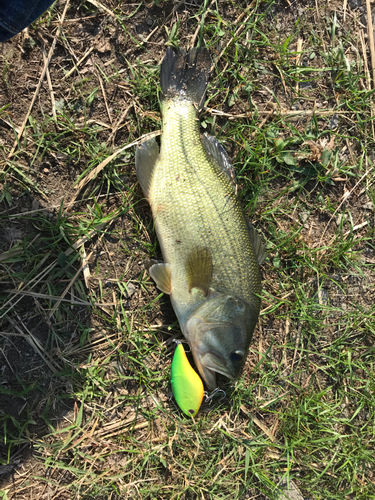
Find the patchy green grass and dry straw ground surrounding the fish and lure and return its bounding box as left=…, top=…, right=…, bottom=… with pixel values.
left=0, top=1, right=375, bottom=500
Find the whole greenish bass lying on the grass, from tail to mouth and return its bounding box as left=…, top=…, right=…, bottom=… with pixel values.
left=135, top=47, right=265, bottom=390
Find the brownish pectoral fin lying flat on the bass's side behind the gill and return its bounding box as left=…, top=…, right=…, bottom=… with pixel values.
left=186, top=247, right=213, bottom=296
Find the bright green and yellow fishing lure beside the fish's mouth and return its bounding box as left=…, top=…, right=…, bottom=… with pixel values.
left=171, top=344, right=204, bottom=417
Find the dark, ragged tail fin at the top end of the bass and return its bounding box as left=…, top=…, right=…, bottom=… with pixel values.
left=160, top=47, right=211, bottom=110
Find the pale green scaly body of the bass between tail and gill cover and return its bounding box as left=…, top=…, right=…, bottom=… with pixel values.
left=150, top=101, right=260, bottom=301
